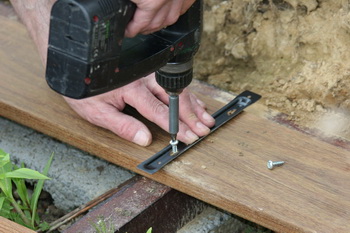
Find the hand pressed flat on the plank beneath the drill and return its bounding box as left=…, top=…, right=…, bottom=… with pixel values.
left=65, top=74, right=215, bottom=146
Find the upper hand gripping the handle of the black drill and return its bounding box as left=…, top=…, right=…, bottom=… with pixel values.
left=125, top=0, right=195, bottom=37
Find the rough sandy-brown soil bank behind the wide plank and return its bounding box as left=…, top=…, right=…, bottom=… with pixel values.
left=195, top=0, right=350, bottom=139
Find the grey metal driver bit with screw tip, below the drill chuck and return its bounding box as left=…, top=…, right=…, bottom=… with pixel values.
left=169, top=93, right=179, bottom=154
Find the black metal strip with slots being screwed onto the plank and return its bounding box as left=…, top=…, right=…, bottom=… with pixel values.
left=137, top=91, right=261, bottom=174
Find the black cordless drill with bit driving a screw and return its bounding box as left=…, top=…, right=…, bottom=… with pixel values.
left=46, top=0, right=202, bottom=153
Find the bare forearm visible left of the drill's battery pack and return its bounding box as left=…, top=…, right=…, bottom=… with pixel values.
left=10, top=0, right=56, bottom=65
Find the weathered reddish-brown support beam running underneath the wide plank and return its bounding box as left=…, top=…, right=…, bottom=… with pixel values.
left=65, top=176, right=207, bottom=233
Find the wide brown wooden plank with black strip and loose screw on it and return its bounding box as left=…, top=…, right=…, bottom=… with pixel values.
left=0, top=17, right=350, bottom=232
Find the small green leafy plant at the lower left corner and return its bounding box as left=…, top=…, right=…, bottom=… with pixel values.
left=0, top=149, right=53, bottom=230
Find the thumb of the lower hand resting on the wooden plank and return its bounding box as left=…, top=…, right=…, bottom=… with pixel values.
left=65, top=96, right=152, bottom=146
